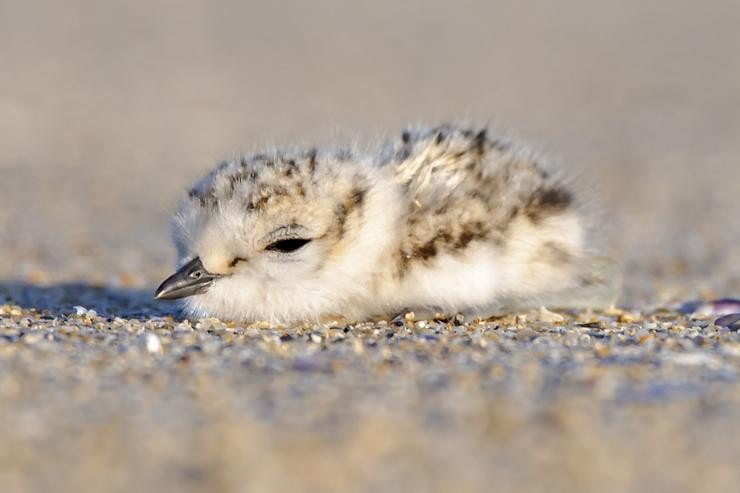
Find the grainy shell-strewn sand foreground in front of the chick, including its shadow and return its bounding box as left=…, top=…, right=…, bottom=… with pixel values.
left=0, top=283, right=740, bottom=491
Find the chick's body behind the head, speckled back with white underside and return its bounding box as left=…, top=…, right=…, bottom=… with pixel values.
left=382, top=126, right=620, bottom=312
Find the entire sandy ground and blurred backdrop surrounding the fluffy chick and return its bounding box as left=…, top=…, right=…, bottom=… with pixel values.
left=0, top=0, right=740, bottom=492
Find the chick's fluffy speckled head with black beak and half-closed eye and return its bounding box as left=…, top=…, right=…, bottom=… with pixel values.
left=155, top=150, right=396, bottom=323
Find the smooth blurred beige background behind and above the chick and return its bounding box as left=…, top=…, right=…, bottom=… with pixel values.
left=0, top=0, right=740, bottom=304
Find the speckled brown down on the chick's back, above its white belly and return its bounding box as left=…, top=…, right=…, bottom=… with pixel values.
left=384, top=126, right=573, bottom=275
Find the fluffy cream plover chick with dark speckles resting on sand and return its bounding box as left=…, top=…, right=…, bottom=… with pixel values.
left=156, top=126, right=616, bottom=325
